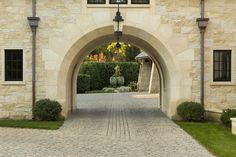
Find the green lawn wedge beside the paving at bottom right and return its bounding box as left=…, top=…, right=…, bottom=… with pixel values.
left=176, top=122, right=236, bottom=157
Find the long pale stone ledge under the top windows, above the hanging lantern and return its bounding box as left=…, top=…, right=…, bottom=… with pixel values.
left=87, top=4, right=151, bottom=8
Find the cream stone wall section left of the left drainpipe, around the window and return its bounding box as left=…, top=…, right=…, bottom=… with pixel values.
left=0, top=0, right=31, bottom=118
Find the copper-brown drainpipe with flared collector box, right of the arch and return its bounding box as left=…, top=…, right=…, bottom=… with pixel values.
left=197, top=0, right=209, bottom=106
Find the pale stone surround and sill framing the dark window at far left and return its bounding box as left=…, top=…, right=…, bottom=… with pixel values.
left=1, top=48, right=25, bottom=85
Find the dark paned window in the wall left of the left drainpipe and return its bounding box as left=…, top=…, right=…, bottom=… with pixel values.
left=5, top=50, right=23, bottom=81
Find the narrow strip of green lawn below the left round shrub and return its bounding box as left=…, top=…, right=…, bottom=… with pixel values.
left=0, top=120, right=63, bottom=130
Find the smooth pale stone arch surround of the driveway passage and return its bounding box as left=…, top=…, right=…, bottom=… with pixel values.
left=57, top=25, right=181, bottom=117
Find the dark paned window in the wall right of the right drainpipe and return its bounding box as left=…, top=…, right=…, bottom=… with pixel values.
left=213, top=50, right=231, bottom=82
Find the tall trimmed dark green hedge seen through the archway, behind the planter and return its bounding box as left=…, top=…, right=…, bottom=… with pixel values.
left=79, top=62, right=139, bottom=90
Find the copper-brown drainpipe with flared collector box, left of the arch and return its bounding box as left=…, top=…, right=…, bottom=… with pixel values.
left=27, top=0, right=40, bottom=119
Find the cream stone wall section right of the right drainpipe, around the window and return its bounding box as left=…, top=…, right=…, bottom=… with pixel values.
left=205, top=0, right=236, bottom=111
